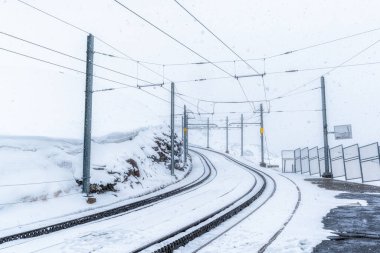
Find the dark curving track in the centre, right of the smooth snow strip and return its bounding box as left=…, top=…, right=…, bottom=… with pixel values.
left=132, top=148, right=276, bottom=253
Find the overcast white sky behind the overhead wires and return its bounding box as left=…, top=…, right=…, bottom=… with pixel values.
left=0, top=0, right=380, bottom=155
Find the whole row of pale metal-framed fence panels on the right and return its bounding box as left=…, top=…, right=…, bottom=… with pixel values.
left=282, top=142, right=380, bottom=183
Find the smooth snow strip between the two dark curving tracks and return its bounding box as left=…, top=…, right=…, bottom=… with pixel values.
left=0, top=148, right=262, bottom=252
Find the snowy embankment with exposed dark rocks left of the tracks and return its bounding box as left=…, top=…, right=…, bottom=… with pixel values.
left=0, top=127, right=188, bottom=230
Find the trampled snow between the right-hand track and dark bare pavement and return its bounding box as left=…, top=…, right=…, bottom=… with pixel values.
left=185, top=159, right=366, bottom=253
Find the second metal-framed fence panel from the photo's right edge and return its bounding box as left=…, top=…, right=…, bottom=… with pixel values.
left=343, top=144, right=362, bottom=180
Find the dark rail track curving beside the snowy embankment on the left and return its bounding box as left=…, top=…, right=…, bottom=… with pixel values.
left=0, top=153, right=212, bottom=244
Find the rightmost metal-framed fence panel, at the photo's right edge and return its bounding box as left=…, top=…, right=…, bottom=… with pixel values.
left=360, top=142, right=380, bottom=182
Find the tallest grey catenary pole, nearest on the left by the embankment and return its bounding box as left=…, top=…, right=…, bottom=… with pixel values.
left=83, top=34, right=94, bottom=196
